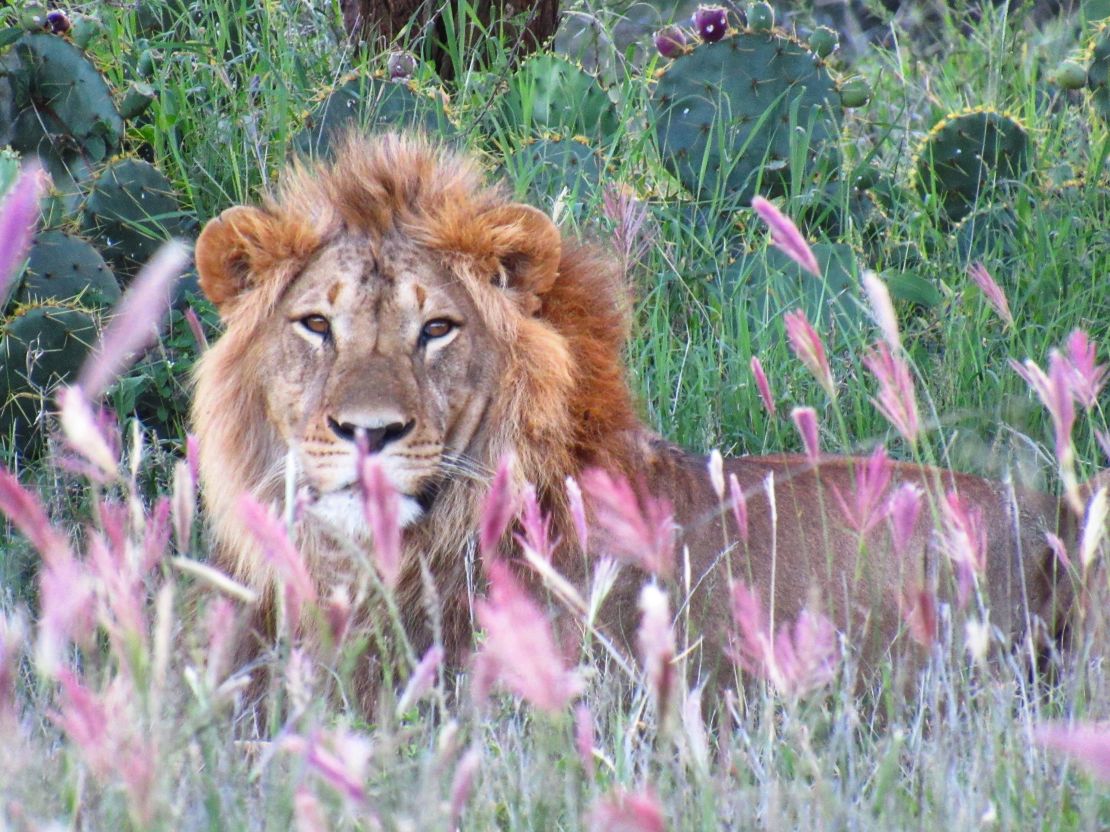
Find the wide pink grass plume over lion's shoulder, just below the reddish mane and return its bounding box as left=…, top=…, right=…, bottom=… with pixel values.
left=582, top=468, right=675, bottom=578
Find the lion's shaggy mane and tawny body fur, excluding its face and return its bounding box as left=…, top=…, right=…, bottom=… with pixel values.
left=193, top=135, right=1067, bottom=705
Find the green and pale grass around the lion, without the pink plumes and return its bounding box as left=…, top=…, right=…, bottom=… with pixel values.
left=0, top=0, right=1110, bottom=830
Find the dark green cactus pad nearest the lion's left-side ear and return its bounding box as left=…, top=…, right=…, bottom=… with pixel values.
left=81, top=159, right=193, bottom=277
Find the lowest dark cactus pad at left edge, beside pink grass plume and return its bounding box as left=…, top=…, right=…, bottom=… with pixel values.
left=0, top=303, right=97, bottom=455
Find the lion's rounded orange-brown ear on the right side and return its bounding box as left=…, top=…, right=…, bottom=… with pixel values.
left=482, top=203, right=563, bottom=295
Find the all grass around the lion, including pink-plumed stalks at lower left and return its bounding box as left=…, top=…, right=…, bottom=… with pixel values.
left=0, top=0, right=1110, bottom=830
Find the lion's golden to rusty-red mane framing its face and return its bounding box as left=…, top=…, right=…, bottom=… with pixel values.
left=193, top=134, right=639, bottom=678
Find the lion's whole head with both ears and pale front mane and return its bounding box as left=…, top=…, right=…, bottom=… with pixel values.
left=193, top=136, right=577, bottom=554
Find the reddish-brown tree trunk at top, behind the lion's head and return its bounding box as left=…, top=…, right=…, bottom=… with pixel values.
left=340, top=0, right=558, bottom=80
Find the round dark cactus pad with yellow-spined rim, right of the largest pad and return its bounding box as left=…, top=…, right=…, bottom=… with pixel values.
left=915, top=109, right=1031, bottom=222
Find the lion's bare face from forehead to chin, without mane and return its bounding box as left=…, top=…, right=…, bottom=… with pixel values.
left=264, top=235, right=501, bottom=527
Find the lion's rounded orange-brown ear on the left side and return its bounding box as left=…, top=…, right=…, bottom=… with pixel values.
left=194, top=205, right=274, bottom=308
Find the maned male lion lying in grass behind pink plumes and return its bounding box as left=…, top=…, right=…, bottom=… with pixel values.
left=193, top=134, right=1070, bottom=705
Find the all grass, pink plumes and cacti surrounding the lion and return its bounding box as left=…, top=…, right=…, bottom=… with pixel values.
left=0, top=0, right=1110, bottom=830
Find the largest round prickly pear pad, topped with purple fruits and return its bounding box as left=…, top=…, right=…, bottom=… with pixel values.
left=652, top=23, right=841, bottom=202
